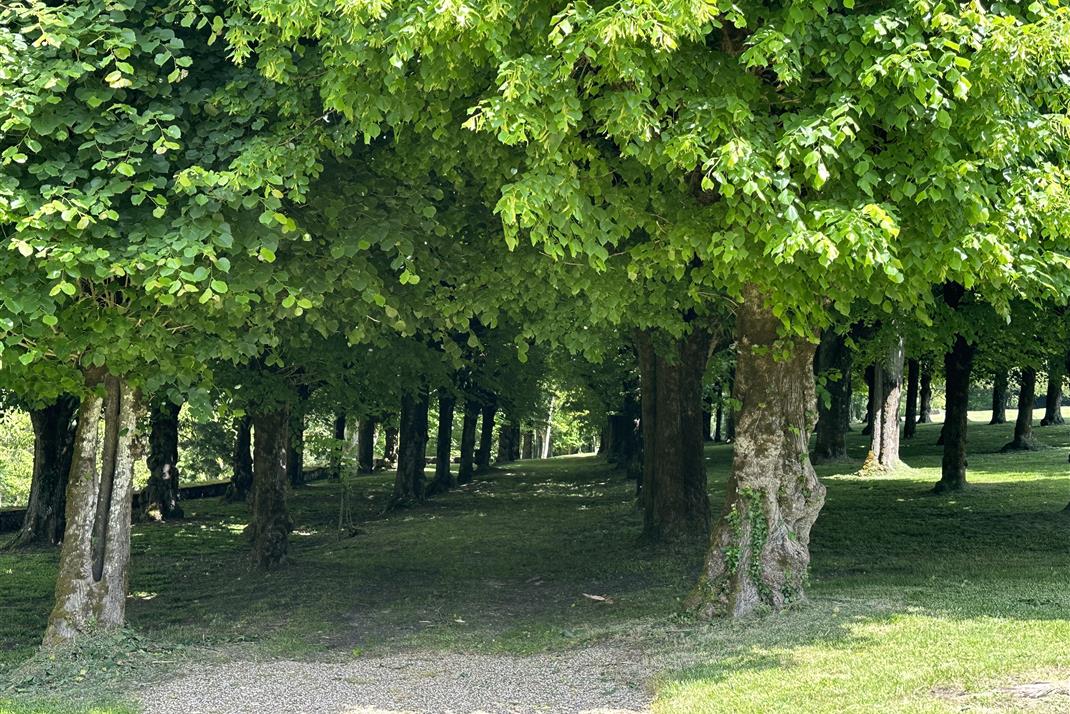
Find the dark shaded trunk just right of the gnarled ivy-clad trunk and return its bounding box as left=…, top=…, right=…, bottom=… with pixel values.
left=812, top=330, right=854, bottom=464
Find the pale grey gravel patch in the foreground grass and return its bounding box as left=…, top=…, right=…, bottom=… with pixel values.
left=138, top=647, right=651, bottom=714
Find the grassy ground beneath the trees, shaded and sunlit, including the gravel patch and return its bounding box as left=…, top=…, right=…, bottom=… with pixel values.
left=0, top=414, right=1070, bottom=714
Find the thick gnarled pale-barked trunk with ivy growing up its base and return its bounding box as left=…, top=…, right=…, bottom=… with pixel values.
left=689, top=288, right=825, bottom=617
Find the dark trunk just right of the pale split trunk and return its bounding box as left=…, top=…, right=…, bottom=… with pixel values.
left=141, top=396, right=182, bottom=520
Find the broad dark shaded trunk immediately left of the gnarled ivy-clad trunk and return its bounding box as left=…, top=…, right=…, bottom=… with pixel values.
left=638, top=328, right=710, bottom=541
